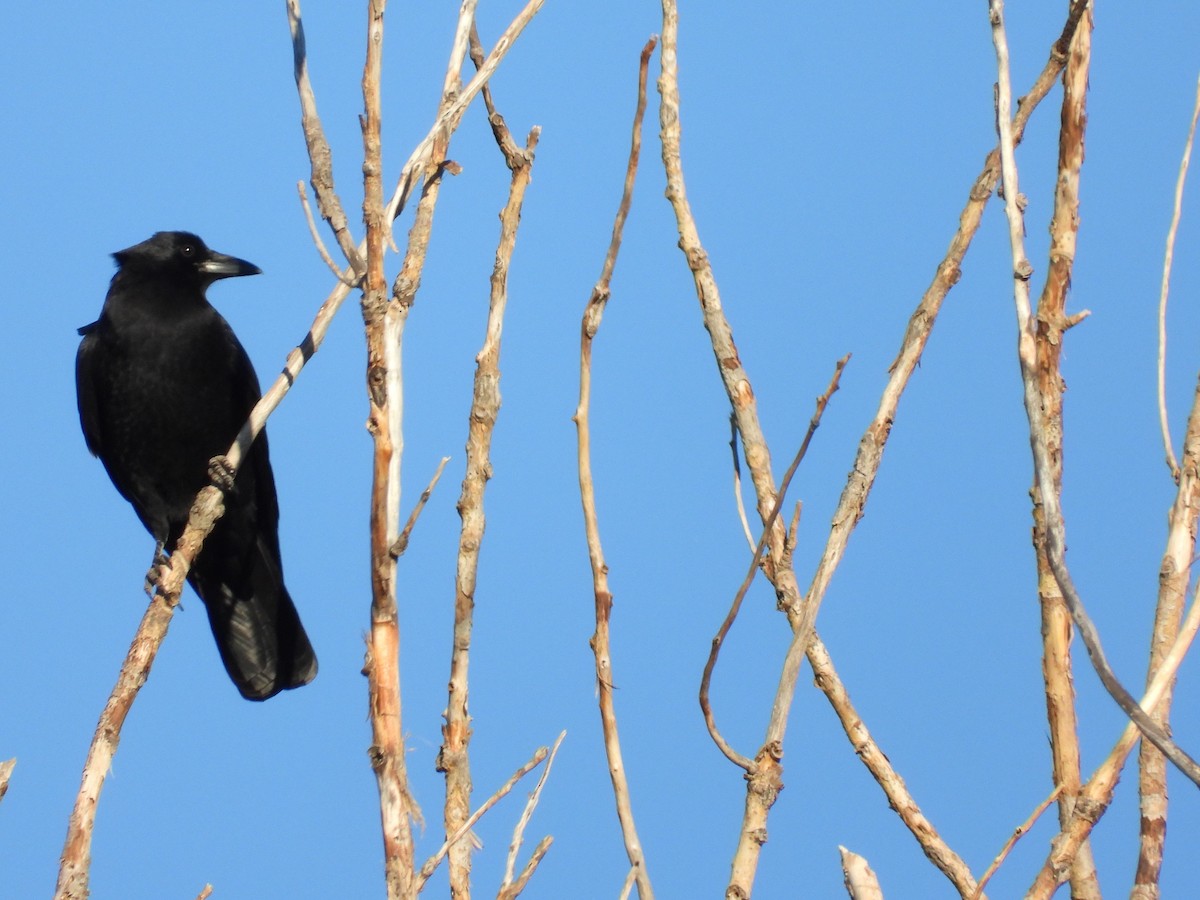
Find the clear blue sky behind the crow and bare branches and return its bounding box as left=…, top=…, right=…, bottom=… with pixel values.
left=0, top=0, right=1200, bottom=900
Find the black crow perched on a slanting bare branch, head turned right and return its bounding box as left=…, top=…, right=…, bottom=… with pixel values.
left=76, top=232, right=317, bottom=700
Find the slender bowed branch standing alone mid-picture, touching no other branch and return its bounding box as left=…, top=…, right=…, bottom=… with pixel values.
left=574, top=37, right=658, bottom=900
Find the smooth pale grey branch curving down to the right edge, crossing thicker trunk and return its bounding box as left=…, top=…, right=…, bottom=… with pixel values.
left=989, top=0, right=1200, bottom=785
